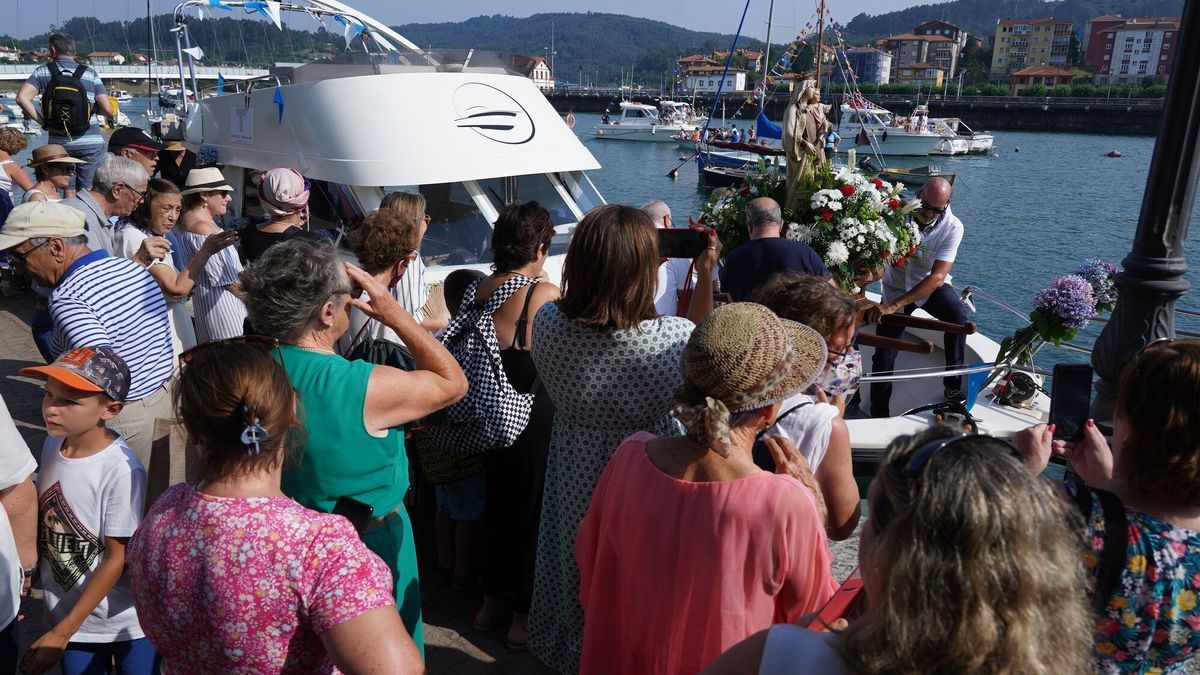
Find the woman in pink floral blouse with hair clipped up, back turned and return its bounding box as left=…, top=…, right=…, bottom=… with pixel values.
left=128, top=344, right=424, bottom=674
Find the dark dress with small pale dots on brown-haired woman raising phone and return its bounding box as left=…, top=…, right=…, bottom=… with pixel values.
left=529, top=303, right=695, bottom=673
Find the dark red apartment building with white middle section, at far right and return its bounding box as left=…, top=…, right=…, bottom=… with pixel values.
left=1084, top=16, right=1180, bottom=84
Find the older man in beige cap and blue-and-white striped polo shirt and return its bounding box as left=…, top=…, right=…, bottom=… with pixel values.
left=0, top=202, right=174, bottom=466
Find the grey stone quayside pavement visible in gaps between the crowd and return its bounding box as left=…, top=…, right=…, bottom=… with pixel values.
left=0, top=288, right=858, bottom=675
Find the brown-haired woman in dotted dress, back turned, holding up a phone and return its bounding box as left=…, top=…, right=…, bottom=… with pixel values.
left=529, top=204, right=720, bottom=673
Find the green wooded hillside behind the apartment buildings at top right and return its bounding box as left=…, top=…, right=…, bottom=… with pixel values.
left=835, top=0, right=1183, bottom=41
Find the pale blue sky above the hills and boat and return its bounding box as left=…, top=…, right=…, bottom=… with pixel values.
left=7, top=0, right=936, bottom=42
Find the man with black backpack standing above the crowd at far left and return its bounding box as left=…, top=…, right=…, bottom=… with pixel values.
left=17, top=32, right=116, bottom=197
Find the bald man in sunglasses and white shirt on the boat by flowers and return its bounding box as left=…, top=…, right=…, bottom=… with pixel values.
left=864, top=178, right=967, bottom=417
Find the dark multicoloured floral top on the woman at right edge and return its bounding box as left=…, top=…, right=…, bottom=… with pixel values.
left=1067, top=483, right=1200, bottom=674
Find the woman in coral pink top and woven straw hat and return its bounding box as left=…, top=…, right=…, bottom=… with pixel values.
left=575, top=303, right=835, bottom=675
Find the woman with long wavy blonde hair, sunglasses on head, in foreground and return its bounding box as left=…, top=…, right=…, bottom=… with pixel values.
left=704, top=428, right=1092, bottom=675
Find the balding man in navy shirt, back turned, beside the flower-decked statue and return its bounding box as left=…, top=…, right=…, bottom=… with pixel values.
left=721, top=197, right=832, bottom=303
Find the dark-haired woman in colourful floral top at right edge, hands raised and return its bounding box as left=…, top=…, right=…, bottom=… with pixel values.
left=1016, top=340, right=1200, bottom=673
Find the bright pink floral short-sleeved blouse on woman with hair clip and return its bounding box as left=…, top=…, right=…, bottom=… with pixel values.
left=127, top=484, right=395, bottom=674
